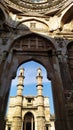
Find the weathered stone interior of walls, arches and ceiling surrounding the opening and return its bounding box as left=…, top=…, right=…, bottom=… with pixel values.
left=0, top=0, right=73, bottom=130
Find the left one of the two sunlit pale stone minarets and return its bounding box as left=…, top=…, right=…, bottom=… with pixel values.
left=11, top=68, right=24, bottom=130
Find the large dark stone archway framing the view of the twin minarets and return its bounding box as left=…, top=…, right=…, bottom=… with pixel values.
left=0, top=34, right=68, bottom=130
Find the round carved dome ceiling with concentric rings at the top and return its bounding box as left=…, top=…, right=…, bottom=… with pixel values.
left=4, top=0, right=66, bottom=14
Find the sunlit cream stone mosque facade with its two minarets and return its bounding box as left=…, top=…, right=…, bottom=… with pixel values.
left=5, top=68, right=55, bottom=130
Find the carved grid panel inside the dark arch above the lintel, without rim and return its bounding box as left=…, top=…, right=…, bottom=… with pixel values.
left=14, top=35, right=52, bottom=50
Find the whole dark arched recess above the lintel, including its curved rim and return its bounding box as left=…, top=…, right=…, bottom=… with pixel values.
left=9, top=33, right=55, bottom=51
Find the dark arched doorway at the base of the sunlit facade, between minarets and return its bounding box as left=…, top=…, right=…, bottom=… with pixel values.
left=23, top=112, right=35, bottom=130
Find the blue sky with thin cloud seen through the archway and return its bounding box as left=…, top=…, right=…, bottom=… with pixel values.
left=10, top=61, right=54, bottom=114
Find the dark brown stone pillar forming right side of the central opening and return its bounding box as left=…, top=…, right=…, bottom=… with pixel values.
left=52, top=53, right=69, bottom=130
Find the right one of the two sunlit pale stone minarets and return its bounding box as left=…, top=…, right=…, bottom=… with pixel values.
left=36, top=68, right=45, bottom=130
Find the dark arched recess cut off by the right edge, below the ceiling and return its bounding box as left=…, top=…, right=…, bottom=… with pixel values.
left=67, top=41, right=73, bottom=80
